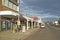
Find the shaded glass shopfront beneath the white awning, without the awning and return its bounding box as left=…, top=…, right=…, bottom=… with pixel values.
left=1, top=19, right=12, bottom=31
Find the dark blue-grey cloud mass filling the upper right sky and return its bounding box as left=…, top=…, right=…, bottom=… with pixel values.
left=23, top=0, right=60, bottom=15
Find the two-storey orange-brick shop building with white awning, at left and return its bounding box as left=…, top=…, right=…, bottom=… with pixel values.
left=0, top=0, right=20, bottom=31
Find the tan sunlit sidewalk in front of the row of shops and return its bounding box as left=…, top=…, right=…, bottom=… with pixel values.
left=0, top=28, right=39, bottom=40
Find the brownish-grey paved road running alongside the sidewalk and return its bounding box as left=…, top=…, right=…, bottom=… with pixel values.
left=24, top=27, right=60, bottom=40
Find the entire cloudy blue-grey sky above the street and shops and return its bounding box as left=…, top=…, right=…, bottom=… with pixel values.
left=20, top=0, right=60, bottom=21
